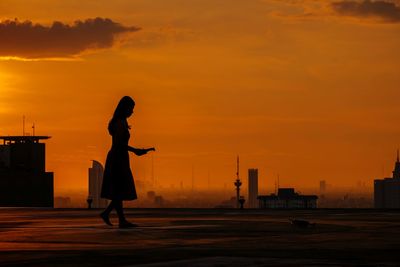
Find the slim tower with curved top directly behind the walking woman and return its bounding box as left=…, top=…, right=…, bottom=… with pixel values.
left=88, top=160, right=108, bottom=208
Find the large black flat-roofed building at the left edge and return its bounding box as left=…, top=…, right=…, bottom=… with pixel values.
left=0, top=136, right=54, bottom=207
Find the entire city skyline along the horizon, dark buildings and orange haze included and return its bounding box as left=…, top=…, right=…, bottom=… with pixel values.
left=0, top=136, right=400, bottom=208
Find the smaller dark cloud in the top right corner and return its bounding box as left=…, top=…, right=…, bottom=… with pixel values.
left=332, top=0, right=400, bottom=23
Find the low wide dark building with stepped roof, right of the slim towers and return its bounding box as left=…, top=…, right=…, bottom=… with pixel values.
left=258, top=188, right=318, bottom=209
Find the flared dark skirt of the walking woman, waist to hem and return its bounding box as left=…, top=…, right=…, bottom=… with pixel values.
left=101, top=149, right=137, bottom=200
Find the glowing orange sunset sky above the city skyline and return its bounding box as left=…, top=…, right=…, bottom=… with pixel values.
left=0, top=0, right=400, bottom=197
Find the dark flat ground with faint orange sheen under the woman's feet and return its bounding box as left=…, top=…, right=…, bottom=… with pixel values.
left=0, top=208, right=400, bottom=267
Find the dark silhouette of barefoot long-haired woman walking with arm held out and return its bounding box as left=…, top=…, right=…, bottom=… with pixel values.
left=100, top=96, right=155, bottom=228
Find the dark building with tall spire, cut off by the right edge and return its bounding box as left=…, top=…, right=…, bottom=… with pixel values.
left=374, top=150, right=400, bottom=209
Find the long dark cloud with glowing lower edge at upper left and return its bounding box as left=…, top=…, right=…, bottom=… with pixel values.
left=0, top=18, right=139, bottom=59
